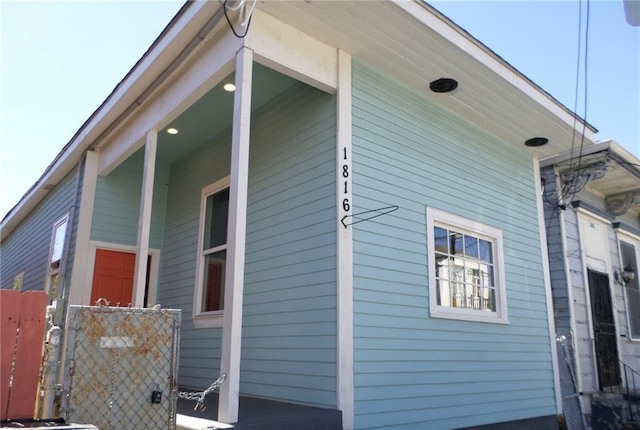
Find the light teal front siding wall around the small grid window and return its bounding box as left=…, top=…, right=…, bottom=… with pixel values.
left=353, top=61, right=556, bottom=430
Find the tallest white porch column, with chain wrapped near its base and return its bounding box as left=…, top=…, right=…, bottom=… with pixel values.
left=218, top=48, right=253, bottom=423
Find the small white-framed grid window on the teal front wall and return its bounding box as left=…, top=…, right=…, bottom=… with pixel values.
left=427, top=208, right=508, bottom=324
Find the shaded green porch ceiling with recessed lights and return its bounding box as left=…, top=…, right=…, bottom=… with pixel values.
left=157, top=63, right=297, bottom=164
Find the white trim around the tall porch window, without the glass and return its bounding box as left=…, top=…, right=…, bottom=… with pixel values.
left=192, top=176, right=231, bottom=328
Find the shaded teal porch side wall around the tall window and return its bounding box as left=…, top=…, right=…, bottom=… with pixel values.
left=159, top=84, right=336, bottom=407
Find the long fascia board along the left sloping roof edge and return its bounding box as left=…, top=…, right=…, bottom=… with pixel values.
left=0, top=1, right=219, bottom=235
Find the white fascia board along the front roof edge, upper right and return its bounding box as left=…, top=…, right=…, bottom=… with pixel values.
left=392, top=0, right=597, bottom=138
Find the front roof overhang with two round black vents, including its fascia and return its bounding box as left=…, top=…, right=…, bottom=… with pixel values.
left=258, top=0, right=595, bottom=158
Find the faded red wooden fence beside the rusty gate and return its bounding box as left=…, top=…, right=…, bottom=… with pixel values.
left=0, top=290, right=48, bottom=420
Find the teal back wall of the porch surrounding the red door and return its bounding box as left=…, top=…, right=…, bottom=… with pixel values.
left=91, top=148, right=169, bottom=249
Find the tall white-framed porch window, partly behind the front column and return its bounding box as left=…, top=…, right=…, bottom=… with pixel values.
left=193, top=177, right=229, bottom=326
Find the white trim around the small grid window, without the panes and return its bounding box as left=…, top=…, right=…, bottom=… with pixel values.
left=427, top=207, right=509, bottom=324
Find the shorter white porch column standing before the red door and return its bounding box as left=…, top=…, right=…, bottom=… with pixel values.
left=133, top=130, right=158, bottom=307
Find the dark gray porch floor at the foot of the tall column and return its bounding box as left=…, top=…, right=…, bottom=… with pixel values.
left=177, top=393, right=342, bottom=430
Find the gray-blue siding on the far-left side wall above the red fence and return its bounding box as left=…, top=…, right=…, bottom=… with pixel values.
left=0, top=167, right=78, bottom=291
